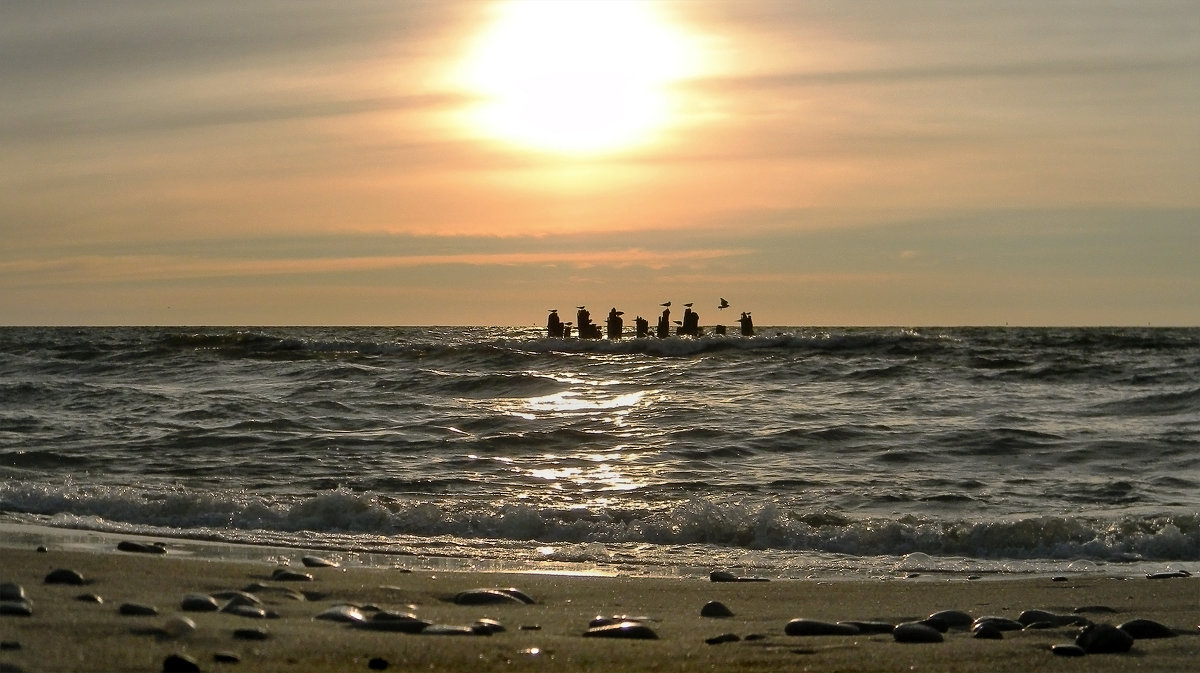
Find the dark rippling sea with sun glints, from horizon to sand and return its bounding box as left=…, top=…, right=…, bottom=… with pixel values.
left=0, top=328, right=1200, bottom=577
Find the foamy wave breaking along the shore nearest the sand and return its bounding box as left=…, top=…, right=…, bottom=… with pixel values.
left=0, top=482, right=1200, bottom=561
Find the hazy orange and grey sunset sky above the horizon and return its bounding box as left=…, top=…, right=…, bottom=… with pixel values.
left=0, top=0, right=1200, bottom=326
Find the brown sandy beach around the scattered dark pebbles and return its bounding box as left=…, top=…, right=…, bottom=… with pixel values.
left=0, top=530, right=1200, bottom=672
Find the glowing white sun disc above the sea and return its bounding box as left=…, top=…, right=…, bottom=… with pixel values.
left=462, top=0, right=689, bottom=155
